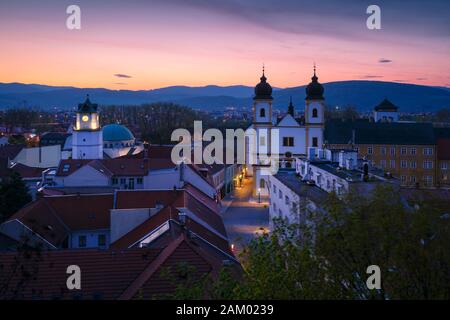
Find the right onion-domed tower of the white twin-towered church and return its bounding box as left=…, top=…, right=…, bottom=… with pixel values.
left=305, top=65, right=325, bottom=150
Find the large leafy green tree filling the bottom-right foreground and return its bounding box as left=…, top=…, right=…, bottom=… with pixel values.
left=170, top=187, right=450, bottom=299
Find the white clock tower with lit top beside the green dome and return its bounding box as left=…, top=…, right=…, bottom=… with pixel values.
left=72, top=95, right=103, bottom=159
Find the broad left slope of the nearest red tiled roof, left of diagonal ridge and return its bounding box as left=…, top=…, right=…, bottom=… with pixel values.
left=0, top=249, right=161, bottom=300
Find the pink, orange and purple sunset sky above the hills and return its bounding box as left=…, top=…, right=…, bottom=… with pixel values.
left=0, top=0, right=450, bottom=90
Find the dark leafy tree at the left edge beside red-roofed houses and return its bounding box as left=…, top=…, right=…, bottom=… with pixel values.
left=0, top=172, right=31, bottom=221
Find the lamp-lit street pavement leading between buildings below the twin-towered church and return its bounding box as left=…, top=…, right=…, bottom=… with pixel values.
left=221, top=178, right=269, bottom=251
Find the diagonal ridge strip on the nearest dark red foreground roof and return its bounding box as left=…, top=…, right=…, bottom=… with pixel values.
left=117, top=234, right=185, bottom=300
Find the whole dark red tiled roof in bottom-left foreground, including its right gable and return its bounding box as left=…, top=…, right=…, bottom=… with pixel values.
left=0, top=234, right=237, bottom=300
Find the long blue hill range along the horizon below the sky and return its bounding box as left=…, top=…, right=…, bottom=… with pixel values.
left=0, top=80, right=450, bottom=112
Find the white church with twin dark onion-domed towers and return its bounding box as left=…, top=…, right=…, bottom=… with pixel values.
left=246, top=66, right=325, bottom=196
